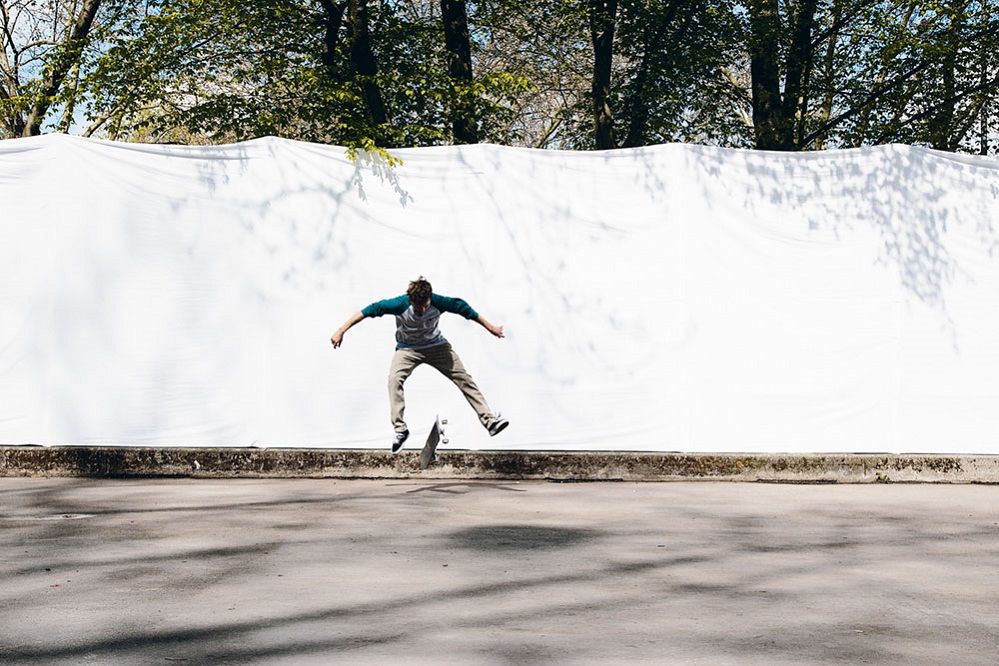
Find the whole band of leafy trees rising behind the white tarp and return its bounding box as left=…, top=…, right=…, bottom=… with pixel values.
left=7, top=0, right=999, bottom=153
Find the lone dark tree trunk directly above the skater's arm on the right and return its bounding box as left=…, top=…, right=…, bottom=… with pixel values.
left=441, top=0, right=479, bottom=143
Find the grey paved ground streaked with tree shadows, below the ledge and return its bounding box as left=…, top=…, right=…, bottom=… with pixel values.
left=0, top=478, right=999, bottom=665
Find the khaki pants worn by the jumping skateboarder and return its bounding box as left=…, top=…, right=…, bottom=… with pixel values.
left=389, top=343, right=493, bottom=432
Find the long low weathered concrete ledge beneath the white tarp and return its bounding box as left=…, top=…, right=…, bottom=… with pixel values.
left=0, top=446, right=999, bottom=483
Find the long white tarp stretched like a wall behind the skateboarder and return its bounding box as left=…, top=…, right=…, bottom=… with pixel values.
left=0, top=135, right=999, bottom=453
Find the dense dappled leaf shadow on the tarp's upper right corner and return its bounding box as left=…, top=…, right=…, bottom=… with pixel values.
left=696, top=145, right=999, bottom=348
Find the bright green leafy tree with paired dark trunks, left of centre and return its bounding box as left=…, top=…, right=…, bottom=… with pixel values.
left=86, top=0, right=422, bottom=146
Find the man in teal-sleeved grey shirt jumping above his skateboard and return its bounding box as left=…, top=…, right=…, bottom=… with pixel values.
left=330, top=275, right=510, bottom=453
